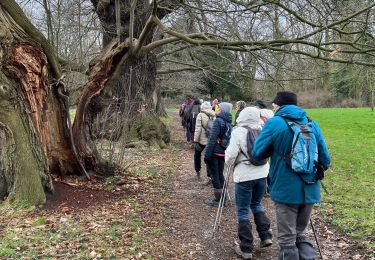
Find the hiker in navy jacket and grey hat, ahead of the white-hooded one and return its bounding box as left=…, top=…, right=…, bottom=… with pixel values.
left=204, top=102, right=233, bottom=206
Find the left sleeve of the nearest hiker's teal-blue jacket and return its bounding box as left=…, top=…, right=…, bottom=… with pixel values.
left=252, top=118, right=277, bottom=161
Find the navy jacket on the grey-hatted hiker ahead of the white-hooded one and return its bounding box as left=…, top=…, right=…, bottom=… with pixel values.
left=204, top=112, right=232, bottom=160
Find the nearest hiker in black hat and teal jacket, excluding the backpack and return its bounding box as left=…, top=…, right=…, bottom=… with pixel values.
left=252, top=91, right=331, bottom=260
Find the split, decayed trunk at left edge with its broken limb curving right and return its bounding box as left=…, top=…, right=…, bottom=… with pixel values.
left=0, top=0, right=134, bottom=204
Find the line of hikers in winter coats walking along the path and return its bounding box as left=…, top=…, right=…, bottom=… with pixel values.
left=180, top=91, right=330, bottom=260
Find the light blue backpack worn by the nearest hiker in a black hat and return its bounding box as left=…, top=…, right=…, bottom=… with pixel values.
left=283, top=117, right=318, bottom=181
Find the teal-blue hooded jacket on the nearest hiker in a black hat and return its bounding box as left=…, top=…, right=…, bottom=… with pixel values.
left=252, top=105, right=331, bottom=205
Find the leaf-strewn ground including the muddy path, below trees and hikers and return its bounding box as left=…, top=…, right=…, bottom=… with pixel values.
left=0, top=110, right=374, bottom=260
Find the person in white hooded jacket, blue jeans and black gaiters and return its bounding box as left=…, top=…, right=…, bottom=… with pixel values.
left=225, top=107, right=272, bottom=259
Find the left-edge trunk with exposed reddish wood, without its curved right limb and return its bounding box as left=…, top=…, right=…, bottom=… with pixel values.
left=0, top=1, right=78, bottom=204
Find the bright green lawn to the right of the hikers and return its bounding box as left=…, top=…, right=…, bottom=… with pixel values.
left=307, top=108, right=375, bottom=248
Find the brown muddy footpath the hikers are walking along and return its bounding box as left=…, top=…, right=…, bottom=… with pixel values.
left=166, top=111, right=371, bottom=260
